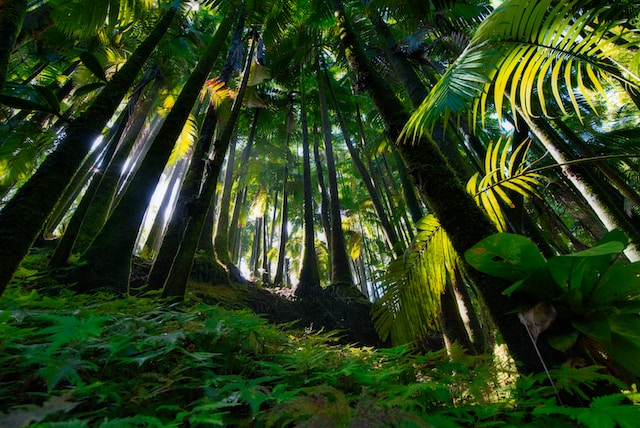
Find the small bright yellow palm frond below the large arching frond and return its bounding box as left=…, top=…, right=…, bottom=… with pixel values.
left=467, top=138, right=546, bottom=231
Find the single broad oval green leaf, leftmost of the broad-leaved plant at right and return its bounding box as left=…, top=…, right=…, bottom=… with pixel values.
left=464, top=233, right=545, bottom=281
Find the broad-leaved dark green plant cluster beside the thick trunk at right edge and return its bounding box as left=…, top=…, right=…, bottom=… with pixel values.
left=465, top=231, right=640, bottom=378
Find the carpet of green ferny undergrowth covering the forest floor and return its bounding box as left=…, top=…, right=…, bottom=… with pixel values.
left=0, top=287, right=640, bottom=428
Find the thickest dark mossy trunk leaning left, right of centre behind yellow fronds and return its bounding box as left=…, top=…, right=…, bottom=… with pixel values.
left=332, top=0, right=541, bottom=372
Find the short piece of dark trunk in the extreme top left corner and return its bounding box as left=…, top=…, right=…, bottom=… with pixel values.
left=0, top=0, right=27, bottom=91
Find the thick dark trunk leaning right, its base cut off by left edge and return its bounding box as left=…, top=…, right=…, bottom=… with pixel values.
left=0, top=6, right=177, bottom=292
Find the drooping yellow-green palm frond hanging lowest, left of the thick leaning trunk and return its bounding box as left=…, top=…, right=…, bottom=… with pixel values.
left=372, top=215, right=459, bottom=344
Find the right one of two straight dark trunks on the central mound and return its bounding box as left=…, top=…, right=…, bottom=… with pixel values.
left=316, top=61, right=353, bottom=286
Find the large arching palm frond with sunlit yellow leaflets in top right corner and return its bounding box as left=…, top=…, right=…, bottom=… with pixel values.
left=404, top=0, right=639, bottom=139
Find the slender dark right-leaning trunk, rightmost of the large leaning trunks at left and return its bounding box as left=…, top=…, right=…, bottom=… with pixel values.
left=163, top=29, right=256, bottom=299
